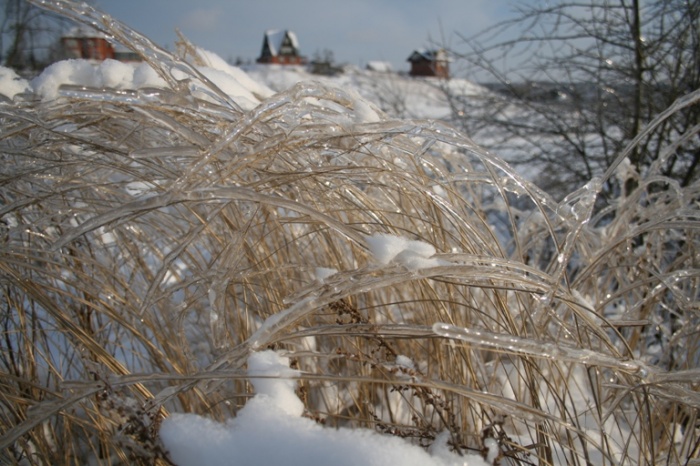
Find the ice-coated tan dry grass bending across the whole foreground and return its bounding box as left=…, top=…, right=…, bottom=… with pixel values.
left=0, top=1, right=700, bottom=464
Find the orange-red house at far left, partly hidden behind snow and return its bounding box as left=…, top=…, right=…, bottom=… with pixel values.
left=61, top=26, right=141, bottom=61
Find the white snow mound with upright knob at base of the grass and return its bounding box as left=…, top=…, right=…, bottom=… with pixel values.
left=160, top=351, right=486, bottom=466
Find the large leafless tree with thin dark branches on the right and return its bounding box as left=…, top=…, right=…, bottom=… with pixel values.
left=450, top=0, right=700, bottom=198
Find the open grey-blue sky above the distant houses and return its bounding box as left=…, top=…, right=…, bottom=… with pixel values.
left=95, top=0, right=515, bottom=71
